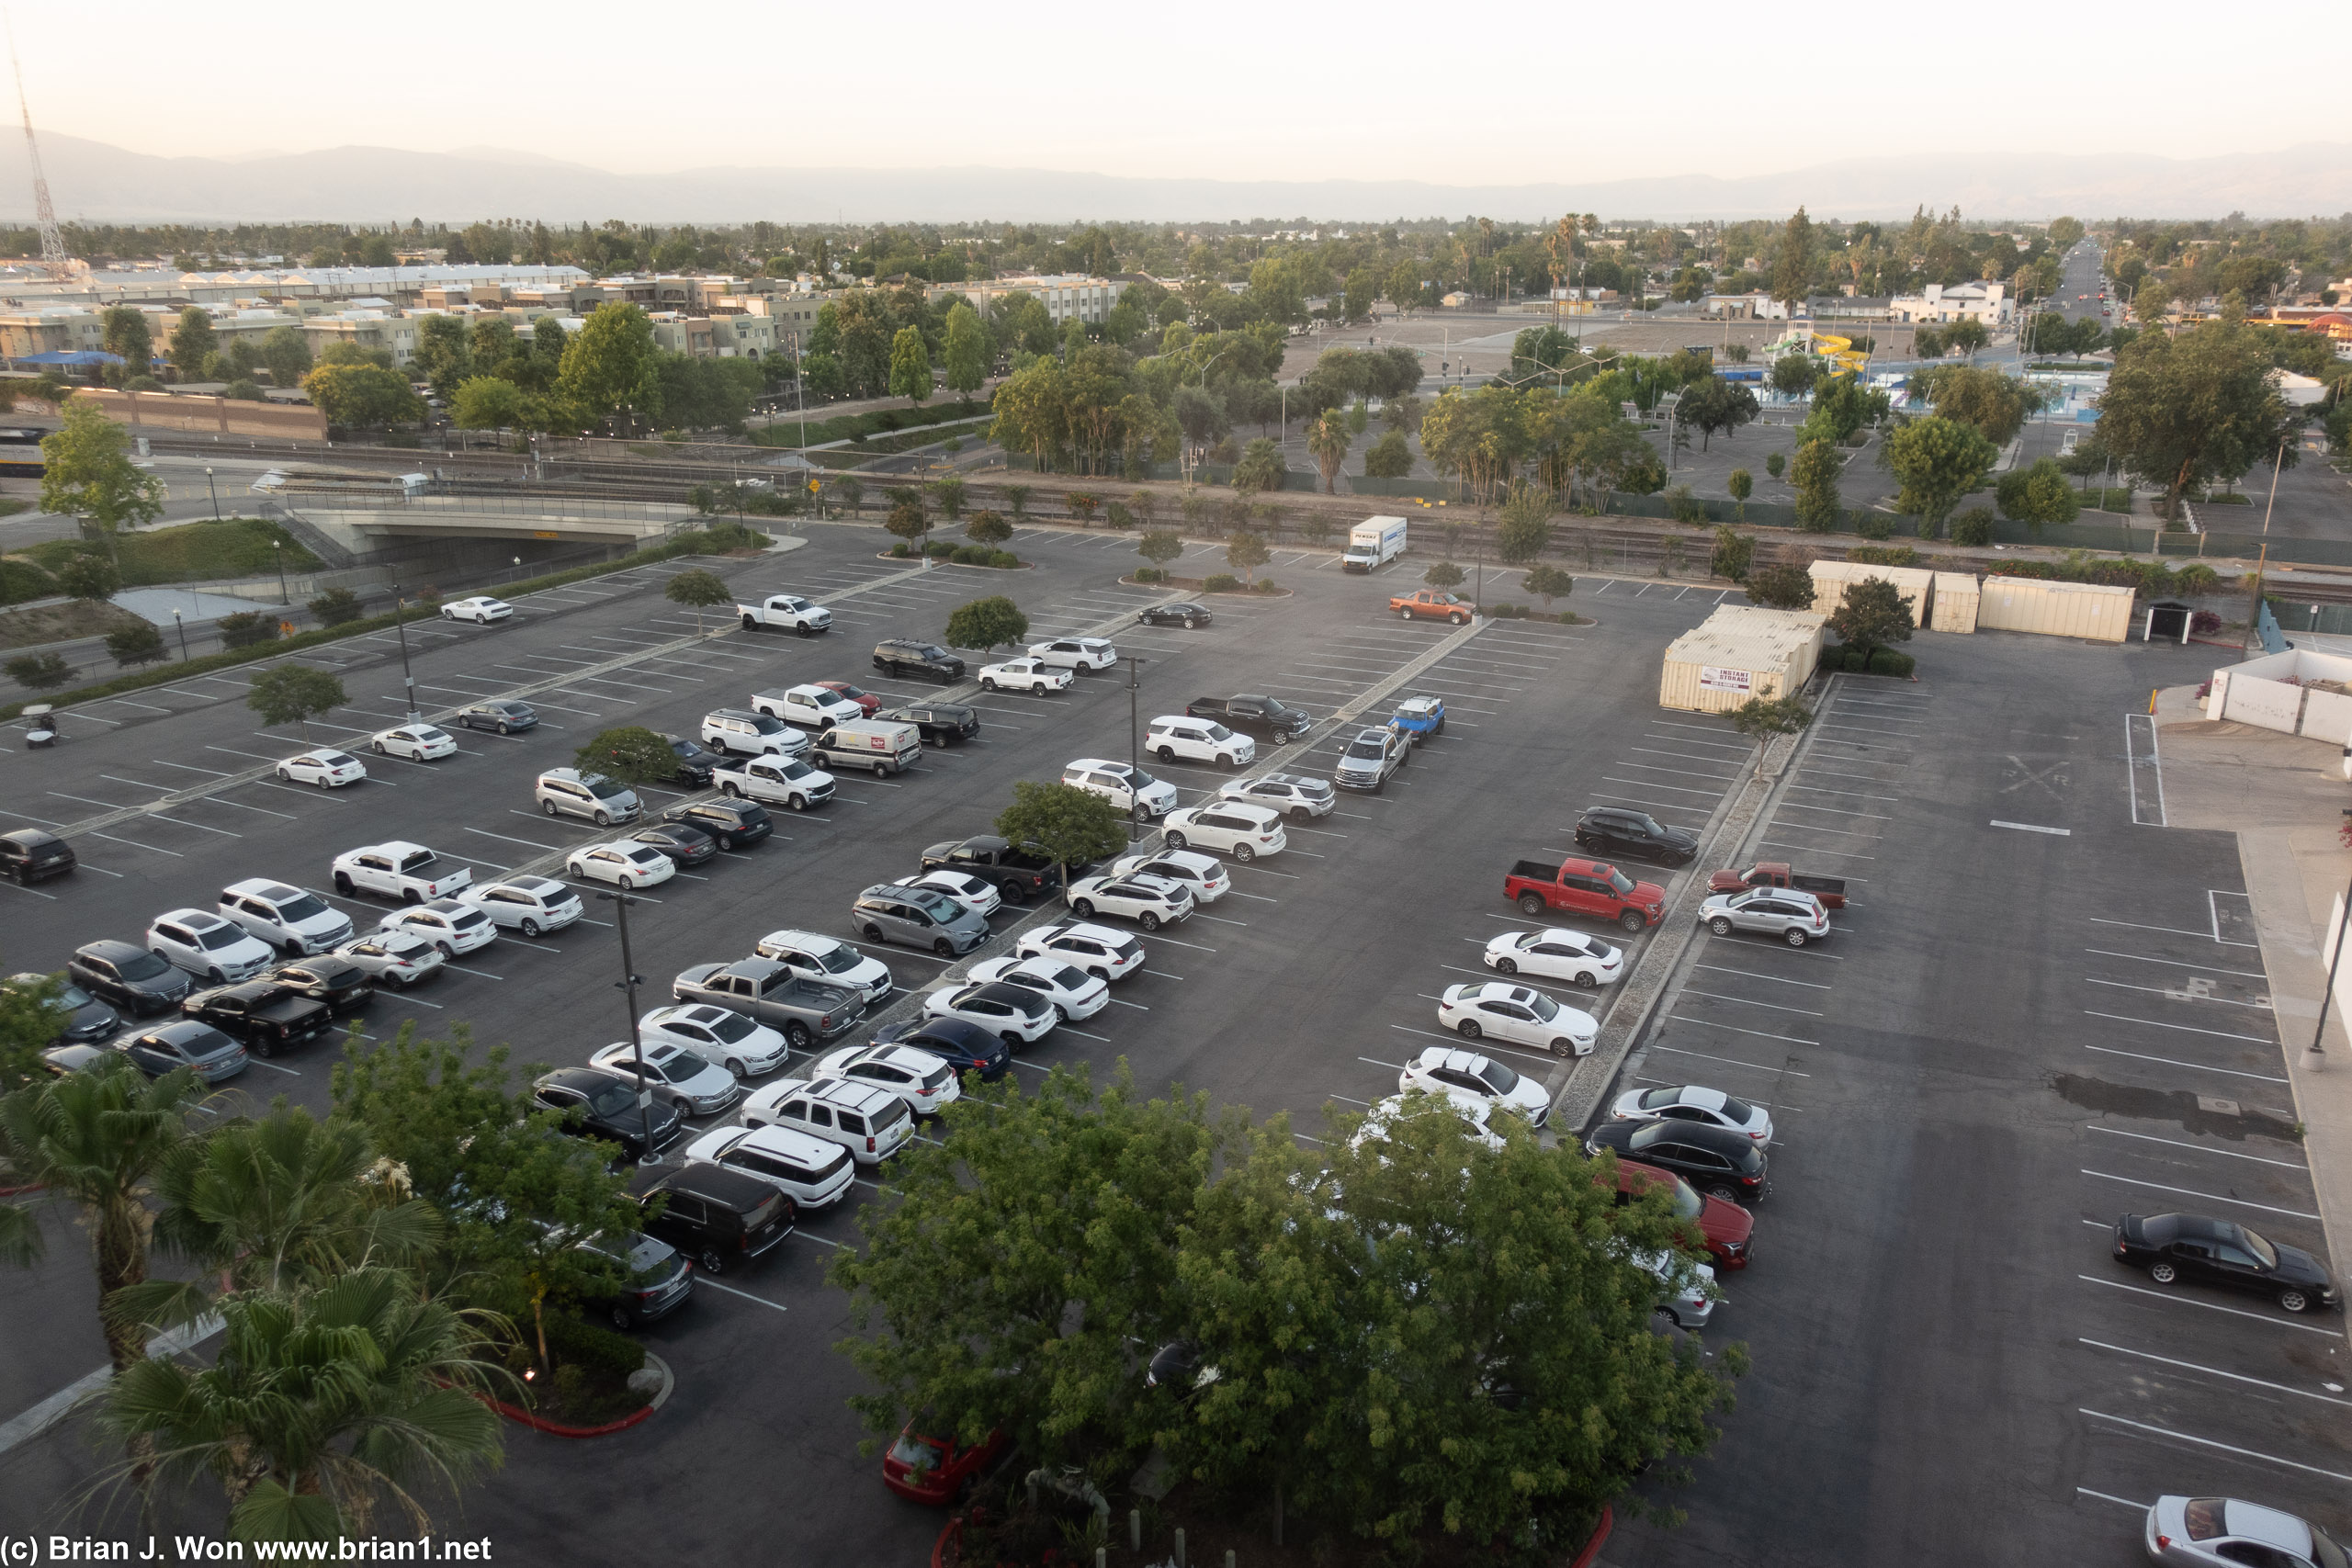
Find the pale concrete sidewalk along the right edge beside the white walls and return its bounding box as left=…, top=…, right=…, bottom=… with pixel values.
left=2157, top=686, right=2352, bottom=1279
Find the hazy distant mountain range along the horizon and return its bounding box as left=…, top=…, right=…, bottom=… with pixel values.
left=0, top=134, right=2352, bottom=223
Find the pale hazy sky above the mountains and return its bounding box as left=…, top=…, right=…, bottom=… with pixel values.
left=12, top=0, right=2345, bottom=184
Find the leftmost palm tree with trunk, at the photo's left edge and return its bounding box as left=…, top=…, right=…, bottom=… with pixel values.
left=0, top=1058, right=202, bottom=1373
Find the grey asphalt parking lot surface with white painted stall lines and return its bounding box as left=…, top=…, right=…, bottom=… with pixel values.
left=0, top=525, right=2352, bottom=1563
